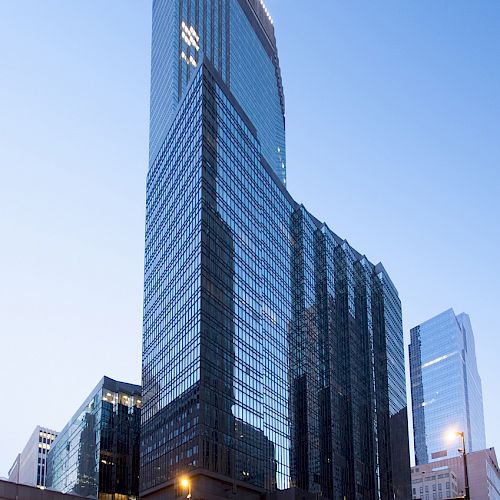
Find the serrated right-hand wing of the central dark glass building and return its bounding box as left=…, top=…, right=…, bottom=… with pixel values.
left=289, top=225, right=410, bottom=498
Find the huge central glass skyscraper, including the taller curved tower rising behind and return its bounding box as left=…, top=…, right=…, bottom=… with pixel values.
left=140, top=0, right=411, bottom=500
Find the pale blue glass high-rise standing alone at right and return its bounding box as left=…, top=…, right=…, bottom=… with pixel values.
left=410, top=309, right=486, bottom=465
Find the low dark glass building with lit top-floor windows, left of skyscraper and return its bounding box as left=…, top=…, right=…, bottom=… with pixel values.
left=47, top=377, right=141, bottom=500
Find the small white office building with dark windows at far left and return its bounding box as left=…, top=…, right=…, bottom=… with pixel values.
left=9, top=425, right=57, bottom=488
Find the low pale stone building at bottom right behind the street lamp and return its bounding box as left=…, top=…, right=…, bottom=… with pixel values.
left=411, top=448, right=500, bottom=500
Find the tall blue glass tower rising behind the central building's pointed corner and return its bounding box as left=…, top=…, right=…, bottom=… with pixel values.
left=149, top=0, right=286, bottom=183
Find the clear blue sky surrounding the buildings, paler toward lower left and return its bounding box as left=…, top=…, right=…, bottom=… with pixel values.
left=0, top=0, right=500, bottom=475
